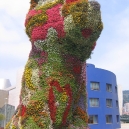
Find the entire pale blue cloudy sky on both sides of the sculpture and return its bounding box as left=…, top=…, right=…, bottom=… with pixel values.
left=0, top=0, right=129, bottom=90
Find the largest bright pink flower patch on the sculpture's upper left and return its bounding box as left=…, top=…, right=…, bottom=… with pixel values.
left=31, top=4, right=65, bottom=42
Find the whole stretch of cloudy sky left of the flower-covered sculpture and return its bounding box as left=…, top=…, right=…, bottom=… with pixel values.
left=0, top=0, right=31, bottom=84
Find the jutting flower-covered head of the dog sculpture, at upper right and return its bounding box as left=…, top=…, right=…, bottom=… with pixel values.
left=62, top=0, right=103, bottom=61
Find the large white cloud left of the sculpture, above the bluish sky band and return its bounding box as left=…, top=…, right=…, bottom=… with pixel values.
left=0, top=0, right=30, bottom=60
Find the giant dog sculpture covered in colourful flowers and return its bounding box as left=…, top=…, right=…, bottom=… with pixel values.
left=6, top=0, right=103, bottom=129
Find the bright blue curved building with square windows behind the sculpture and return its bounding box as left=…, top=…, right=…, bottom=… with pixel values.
left=86, top=64, right=120, bottom=129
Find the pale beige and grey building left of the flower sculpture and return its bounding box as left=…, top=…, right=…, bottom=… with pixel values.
left=0, top=69, right=23, bottom=129
